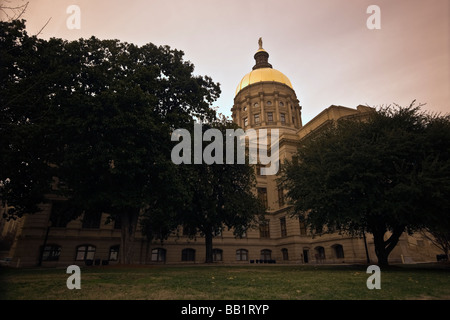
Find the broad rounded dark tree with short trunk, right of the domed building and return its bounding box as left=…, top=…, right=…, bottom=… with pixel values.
left=282, top=102, right=450, bottom=265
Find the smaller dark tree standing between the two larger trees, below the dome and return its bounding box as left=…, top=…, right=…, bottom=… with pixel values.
left=178, top=119, right=265, bottom=263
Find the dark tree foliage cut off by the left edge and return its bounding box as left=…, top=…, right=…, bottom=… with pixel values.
left=0, top=20, right=56, bottom=219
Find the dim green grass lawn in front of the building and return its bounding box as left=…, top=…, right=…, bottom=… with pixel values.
left=0, top=264, right=450, bottom=300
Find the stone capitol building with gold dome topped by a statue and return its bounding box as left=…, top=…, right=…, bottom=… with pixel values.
left=0, top=39, right=439, bottom=267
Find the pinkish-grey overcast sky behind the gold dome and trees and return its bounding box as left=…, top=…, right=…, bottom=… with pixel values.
left=1, top=0, right=450, bottom=123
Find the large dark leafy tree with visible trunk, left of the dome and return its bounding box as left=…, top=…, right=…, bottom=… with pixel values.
left=51, top=38, right=220, bottom=263
